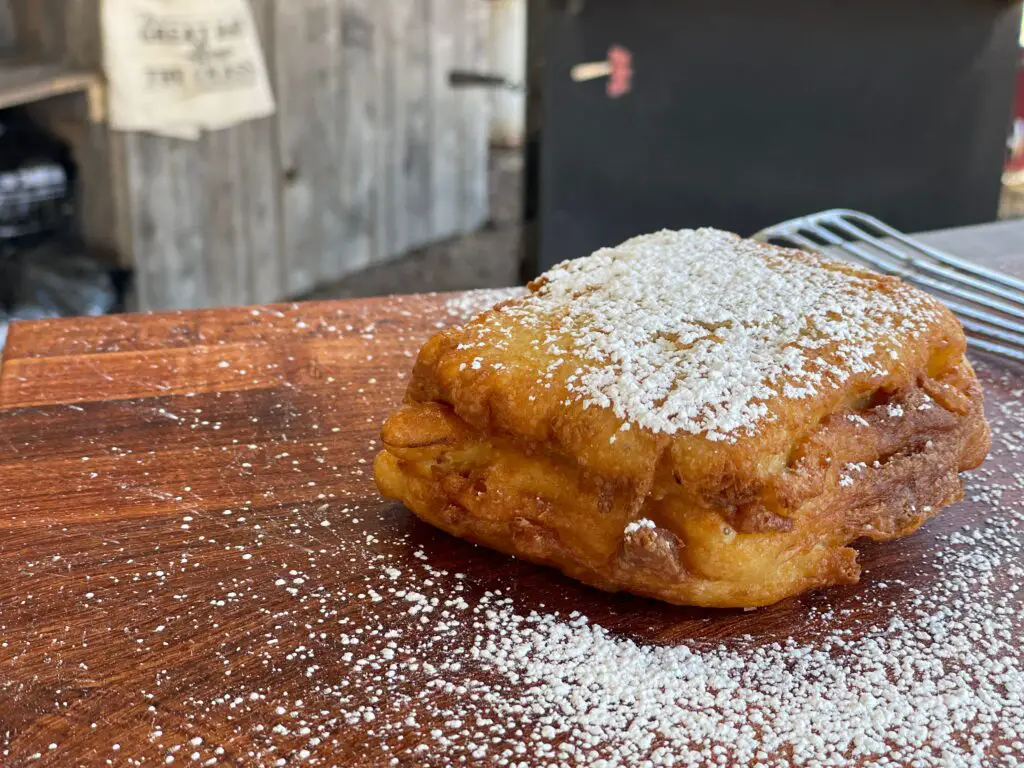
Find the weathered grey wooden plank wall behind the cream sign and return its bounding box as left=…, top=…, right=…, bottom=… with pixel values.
left=4, top=0, right=487, bottom=309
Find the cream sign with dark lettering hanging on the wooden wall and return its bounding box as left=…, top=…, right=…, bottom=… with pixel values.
left=102, top=0, right=274, bottom=139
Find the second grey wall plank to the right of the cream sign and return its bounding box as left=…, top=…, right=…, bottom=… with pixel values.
left=339, top=0, right=383, bottom=271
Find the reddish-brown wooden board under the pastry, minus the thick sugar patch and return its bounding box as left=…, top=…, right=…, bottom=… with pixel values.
left=0, top=228, right=1024, bottom=766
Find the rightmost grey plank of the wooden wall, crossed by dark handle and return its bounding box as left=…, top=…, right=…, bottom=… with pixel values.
left=458, top=0, right=489, bottom=231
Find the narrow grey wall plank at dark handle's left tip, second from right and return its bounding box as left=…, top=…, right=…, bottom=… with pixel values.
left=430, top=0, right=463, bottom=239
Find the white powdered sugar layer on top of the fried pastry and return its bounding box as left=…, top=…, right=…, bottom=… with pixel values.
left=476, top=229, right=939, bottom=439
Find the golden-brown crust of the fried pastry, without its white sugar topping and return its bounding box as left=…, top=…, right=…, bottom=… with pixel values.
left=375, top=228, right=988, bottom=606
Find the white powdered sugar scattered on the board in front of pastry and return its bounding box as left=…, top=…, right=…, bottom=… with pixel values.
left=174, top=368, right=1024, bottom=768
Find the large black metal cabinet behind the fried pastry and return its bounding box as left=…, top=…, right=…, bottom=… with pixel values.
left=525, top=0, right=1021, bottom=276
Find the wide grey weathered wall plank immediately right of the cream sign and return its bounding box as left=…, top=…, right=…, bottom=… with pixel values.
left=273, top=0, right=344, bottom=295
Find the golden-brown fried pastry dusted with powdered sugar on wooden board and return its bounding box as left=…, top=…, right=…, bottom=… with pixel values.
left=374, top=229, right=989, bottom=607
